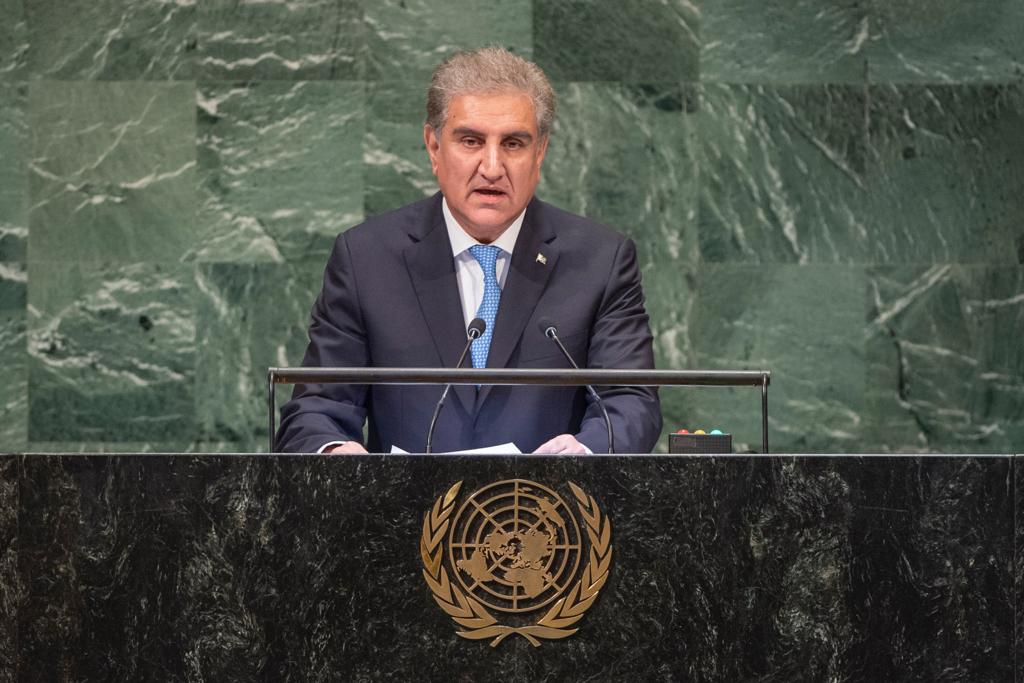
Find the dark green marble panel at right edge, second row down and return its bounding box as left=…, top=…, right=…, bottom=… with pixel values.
left=859, top=85, right=1024, bottom=263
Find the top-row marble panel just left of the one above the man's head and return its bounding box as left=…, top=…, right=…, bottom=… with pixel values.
left=197, top=0, right=367, bottom=82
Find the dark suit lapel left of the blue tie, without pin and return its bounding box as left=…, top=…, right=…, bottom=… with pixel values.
left=403, top=195, right=476, bottom=412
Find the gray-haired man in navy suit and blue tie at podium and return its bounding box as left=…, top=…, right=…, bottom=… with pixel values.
left=275, top=48, right=662, bottom=454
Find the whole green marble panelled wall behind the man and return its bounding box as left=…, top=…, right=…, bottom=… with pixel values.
left=0, top=0, right=1024, bottom=452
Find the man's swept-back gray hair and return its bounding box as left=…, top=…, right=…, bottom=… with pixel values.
left=427, top=47, right=555, bottom=137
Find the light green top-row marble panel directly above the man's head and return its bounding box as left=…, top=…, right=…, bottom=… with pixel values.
left=366, top=0, right=534, bottom=81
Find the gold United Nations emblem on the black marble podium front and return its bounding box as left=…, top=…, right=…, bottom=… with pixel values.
left=420, top=479, right=611, bottom=647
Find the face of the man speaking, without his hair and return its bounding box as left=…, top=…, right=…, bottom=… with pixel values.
left=423, top=92, right=548, bottom=244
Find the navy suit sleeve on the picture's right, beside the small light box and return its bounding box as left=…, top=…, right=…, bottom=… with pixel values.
left=577, top=240, right=662, bottom=453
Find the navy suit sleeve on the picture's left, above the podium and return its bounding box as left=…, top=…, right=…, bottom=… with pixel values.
left=274, top=233, right=370, bottom=453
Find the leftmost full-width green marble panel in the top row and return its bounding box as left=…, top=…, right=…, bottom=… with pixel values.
left=26, top=0, right=197, bottom=81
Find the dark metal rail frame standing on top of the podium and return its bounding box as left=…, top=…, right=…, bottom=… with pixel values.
left=267, top=368, right=771, bottom=454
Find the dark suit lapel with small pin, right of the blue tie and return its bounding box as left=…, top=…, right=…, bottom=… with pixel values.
left=476, top=200, right=558, bottom=410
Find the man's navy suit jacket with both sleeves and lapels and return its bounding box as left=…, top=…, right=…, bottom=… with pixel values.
left=276, top=194, right=662, bottom=453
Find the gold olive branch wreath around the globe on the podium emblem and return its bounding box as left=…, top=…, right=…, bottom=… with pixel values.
left=420, top=481, right=611, bottom=647
